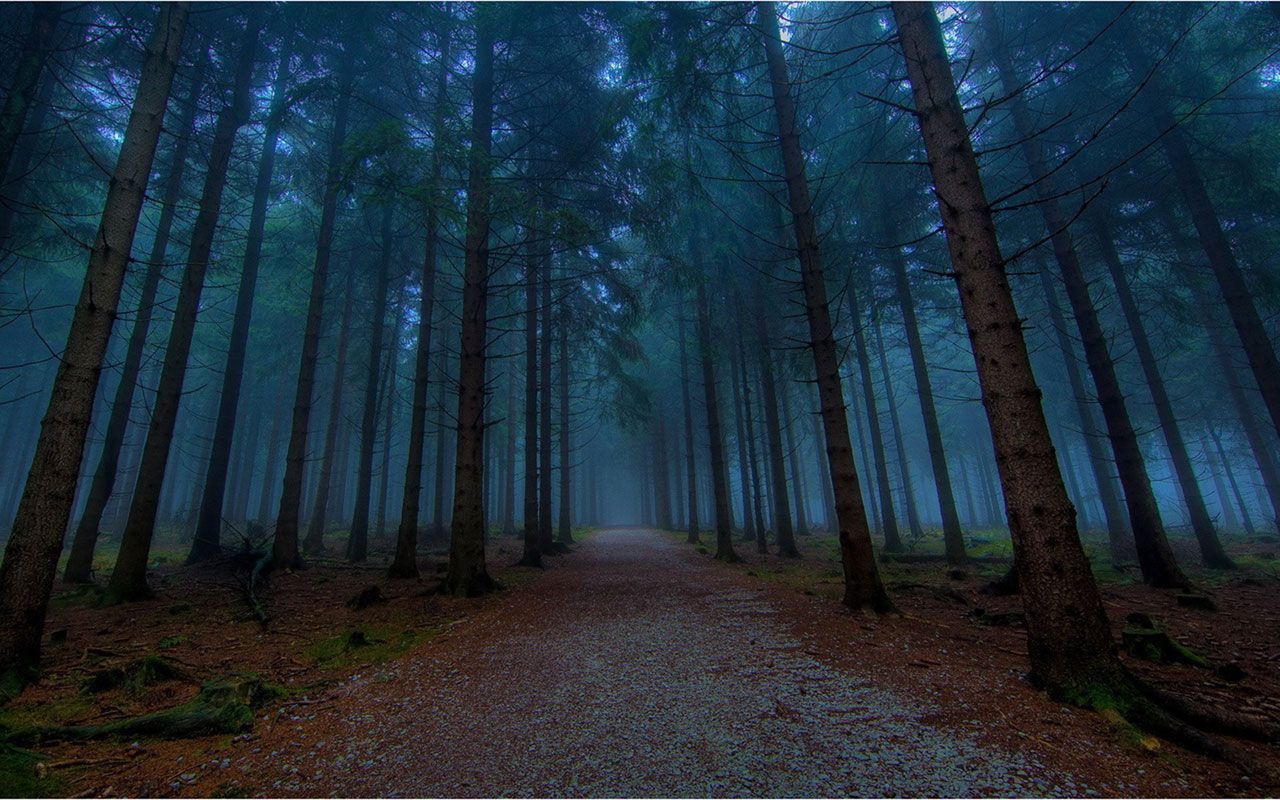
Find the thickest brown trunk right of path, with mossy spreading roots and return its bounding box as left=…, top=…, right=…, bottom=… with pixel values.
left=892, top=3, right=1125, bottom=703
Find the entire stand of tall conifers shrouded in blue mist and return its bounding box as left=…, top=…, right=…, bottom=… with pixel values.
left=0, top=3, right=1280, bottom=755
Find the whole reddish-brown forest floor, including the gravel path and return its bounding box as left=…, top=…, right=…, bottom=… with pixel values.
left=0, top=530, right=1280, bottom=796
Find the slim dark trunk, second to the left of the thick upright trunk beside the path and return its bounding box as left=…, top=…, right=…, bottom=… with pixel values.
left=347, top=202, right=394, bottom=563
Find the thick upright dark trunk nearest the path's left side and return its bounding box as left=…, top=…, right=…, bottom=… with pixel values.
left=444, top=6, right=495, bottom=596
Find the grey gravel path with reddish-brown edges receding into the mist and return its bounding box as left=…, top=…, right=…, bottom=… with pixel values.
left=227, top=530, right=1087, bottom=796
